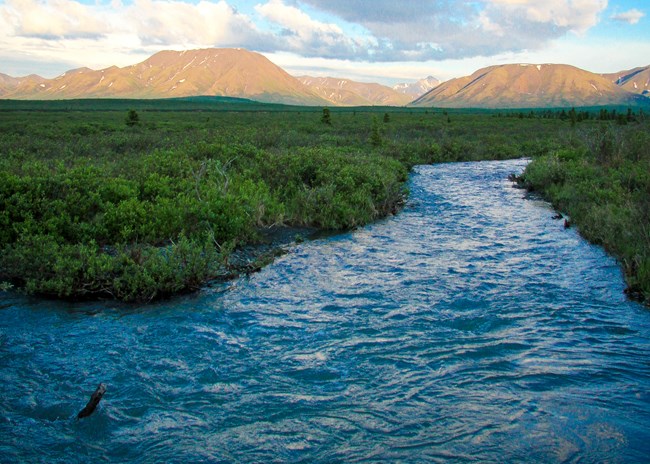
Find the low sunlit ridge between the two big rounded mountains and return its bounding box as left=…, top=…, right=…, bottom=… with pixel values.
left=298, top=76, right=412, bottom=106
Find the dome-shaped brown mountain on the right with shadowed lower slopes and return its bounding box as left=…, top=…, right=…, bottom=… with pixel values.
left=413, top=64, right=640, bottom=108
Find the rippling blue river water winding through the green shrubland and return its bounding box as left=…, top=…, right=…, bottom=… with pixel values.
left=0, top=160, right=650, bottom=463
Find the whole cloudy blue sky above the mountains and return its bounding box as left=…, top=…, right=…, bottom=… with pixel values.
left=0, top=0, right=650, bottom=85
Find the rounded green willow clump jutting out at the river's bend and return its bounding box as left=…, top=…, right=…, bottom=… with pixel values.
left=256, top=147, right=408, bottom=229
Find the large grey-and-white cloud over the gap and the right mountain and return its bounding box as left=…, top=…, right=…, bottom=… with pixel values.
left=294, top=0, right=607, bottom=61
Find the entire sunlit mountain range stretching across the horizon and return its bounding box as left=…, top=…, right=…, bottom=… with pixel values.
left=0, top=48, right=650, bottom=108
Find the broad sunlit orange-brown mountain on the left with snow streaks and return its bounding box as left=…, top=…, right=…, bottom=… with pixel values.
left=0, top=48, right=328, bottom=105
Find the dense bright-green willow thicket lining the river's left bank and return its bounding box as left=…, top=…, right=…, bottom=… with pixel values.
left=0, top=129, right=407, bottom=301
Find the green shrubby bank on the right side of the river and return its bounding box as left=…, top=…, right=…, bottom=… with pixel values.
left=521, top=122, right=650, bottom=303
